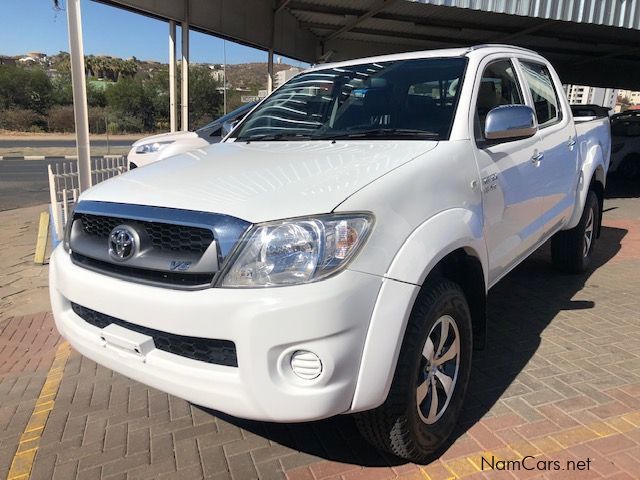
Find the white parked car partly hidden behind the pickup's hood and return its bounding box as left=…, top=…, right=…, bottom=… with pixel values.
left=127, top=102, right=257, bottom=169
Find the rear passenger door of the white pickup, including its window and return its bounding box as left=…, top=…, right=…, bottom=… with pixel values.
left=518, top=58, right=578, bottom=232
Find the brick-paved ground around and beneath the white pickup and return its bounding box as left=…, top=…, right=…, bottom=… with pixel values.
left=0, top=178, right=640, bottom=480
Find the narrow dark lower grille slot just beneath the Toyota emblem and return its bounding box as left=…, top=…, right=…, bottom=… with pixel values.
left=71, top=252, right=214, bottom=289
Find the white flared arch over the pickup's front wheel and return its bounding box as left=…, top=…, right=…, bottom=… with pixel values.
left=350, top=209, right=487, bottom=412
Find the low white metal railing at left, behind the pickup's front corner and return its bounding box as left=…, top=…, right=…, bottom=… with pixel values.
left=47, top=155, right=129, bottom=241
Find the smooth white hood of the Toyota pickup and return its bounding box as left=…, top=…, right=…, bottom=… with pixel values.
left=81, top=140, right=438, bottom=223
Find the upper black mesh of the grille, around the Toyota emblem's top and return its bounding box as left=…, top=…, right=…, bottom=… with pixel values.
left=75, top=213, right=213, bottom=255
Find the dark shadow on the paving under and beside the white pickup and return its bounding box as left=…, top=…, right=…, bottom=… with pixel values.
left=199, top=227, right=627, bottom=467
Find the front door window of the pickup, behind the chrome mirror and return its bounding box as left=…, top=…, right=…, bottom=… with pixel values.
left=474, top=60, right=524, bottom=141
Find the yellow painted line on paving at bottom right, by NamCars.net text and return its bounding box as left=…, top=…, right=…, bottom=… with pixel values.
left=420, top=412, right=640, bottom=480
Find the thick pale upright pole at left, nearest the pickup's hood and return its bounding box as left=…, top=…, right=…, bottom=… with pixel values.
left=67, top=0, right=91, bottom=192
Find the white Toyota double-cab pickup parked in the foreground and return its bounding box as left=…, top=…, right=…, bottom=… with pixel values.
left=50, top=45, right=611, bottom=461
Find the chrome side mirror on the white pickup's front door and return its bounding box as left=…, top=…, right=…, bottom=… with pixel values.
left=484, top=105, right=538, bottom=141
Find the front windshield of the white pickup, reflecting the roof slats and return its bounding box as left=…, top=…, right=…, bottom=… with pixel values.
left=233, top=57, right=466, bottom=141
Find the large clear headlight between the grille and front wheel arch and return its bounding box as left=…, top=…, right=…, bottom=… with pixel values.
left=220, top=213, right=373, bottom=287
